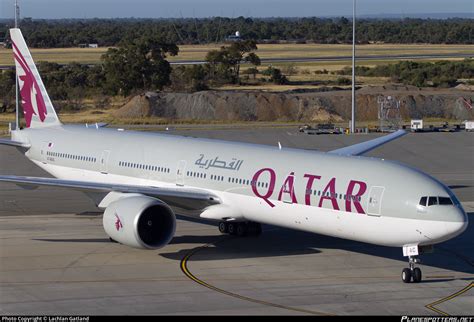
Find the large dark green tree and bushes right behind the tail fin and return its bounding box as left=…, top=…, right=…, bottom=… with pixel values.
left=0, top=36, right=179, bottom=110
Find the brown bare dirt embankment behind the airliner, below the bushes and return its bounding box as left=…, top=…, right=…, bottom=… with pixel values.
left=114, top=86, right=474, bottom=122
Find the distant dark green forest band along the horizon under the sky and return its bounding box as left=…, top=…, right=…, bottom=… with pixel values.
left=0, top=17, right=474, bottom=48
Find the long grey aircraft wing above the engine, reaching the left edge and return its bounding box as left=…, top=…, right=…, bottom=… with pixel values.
left=0, top=176, right=221, bottom=210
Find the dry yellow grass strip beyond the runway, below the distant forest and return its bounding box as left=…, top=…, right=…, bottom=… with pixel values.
left=0, top=44, right=474, bottom=66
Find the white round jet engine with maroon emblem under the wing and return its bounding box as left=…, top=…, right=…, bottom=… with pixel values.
left=102, top=196, right=176, bottom=249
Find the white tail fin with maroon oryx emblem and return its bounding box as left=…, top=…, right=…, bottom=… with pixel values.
left=10, top=28, right=61, bottom=128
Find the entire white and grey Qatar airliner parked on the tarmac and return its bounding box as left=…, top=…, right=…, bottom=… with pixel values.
left=0, top=29, right=468, bottom=283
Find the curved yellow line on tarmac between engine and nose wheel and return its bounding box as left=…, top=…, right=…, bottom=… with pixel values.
left=180, top=238, right=332, bottom=315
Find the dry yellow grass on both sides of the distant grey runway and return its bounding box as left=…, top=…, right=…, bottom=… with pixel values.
left=0, top=44, right=474, bottom=91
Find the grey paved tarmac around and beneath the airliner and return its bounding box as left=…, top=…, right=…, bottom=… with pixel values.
left=0, top=127, right=474, bottom=315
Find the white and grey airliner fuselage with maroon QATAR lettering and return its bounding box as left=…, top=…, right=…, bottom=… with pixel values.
left=12, top=126, right=467, bottom=246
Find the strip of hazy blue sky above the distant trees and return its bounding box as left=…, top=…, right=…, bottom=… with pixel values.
left=0, top=0, right=474, bottom=18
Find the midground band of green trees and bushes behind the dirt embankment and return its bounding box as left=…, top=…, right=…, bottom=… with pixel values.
left=0, top=35, right=474, bottom=110
